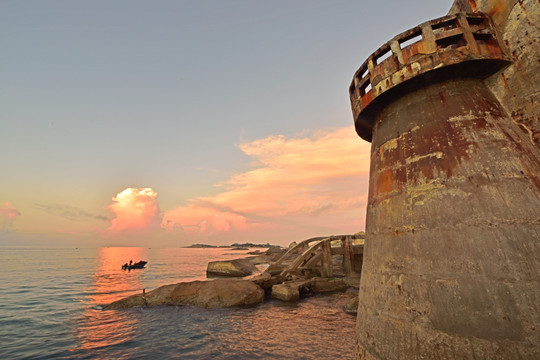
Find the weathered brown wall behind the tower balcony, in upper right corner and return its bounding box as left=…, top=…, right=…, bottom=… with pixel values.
left=450, top=0, right=540, bottom=148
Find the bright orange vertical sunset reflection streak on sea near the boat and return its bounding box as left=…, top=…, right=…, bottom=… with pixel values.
left=70, top=247, right=148, bottom=358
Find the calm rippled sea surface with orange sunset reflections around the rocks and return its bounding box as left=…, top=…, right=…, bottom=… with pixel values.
left=0, top=247, right=355, bottom=359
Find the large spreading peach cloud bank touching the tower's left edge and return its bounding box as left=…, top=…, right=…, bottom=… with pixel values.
left=162, top=127, right=370, bottom=240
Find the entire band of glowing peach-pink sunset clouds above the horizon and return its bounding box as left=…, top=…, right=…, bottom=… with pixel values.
left=0, top=127, right=369, bottom=245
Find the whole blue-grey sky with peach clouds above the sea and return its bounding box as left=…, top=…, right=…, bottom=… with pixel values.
left=0, top=0, right=452, bottom=247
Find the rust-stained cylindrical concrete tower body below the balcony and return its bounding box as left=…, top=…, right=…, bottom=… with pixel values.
left=357, top=79, right=540, bottom=359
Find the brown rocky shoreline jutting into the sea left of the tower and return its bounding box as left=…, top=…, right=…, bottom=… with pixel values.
left=103, top=240, right=358, bottom=314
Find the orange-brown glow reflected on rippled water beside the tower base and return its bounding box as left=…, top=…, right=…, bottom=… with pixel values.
left=207, top=294, right=355, bottom=359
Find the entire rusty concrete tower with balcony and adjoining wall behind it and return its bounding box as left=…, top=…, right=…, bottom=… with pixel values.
left=349, top=0, right=540, bottom=359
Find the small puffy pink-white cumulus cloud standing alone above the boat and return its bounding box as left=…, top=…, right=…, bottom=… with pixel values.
left=108, top=188, right=160, bottom=231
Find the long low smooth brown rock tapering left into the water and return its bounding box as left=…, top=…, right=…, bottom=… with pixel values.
left=104, top=279, right=264, bottom=310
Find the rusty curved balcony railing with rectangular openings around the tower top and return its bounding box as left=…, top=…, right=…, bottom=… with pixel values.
left=349, top=13, right=510, bottom=141
